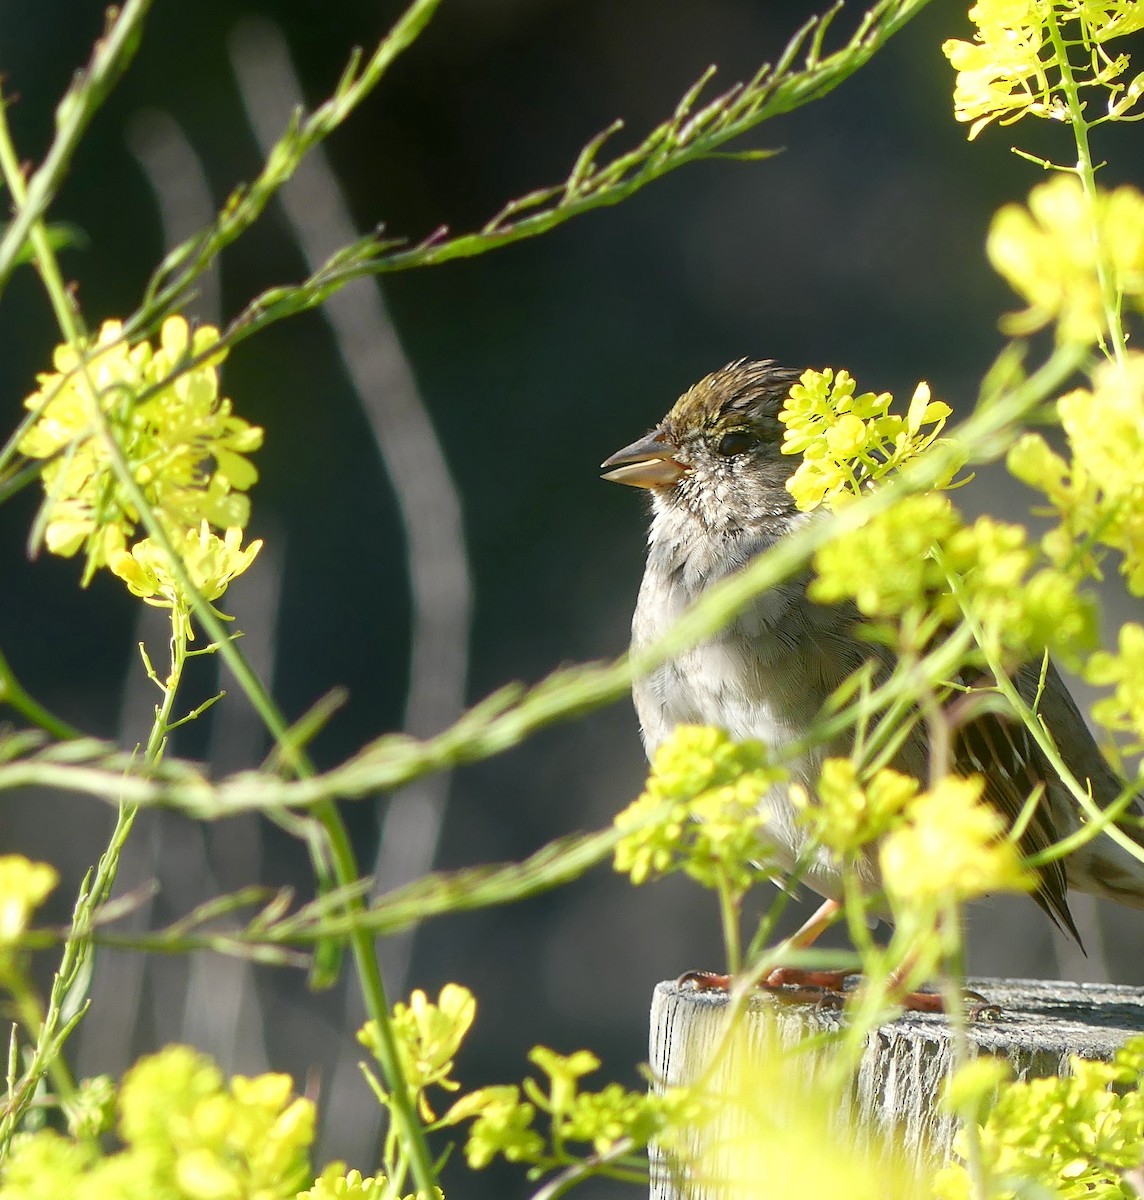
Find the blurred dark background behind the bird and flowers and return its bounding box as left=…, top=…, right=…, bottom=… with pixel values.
left=0, top=0, right=1144, bottom=1195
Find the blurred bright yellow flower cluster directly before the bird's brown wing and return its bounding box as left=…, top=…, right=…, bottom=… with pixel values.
left=879, top=775, right=1036, bottom=912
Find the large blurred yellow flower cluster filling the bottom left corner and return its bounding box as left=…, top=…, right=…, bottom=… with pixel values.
left=0, top=1046, right=315, bottom=1200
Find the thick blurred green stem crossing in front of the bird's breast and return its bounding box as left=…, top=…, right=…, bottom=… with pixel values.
left=0, top=346, right=1084, bottom=820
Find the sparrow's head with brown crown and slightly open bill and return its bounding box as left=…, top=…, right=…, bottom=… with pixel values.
left=603, top=359, right=802, bottom=529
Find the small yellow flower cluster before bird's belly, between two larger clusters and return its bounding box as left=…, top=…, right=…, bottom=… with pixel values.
left=790, top=758, right=918, bottom=859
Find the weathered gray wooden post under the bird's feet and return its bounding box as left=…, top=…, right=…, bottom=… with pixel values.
left=648, top=979, right=1144, bottom=1200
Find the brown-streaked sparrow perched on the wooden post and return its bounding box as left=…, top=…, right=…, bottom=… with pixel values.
left=603, top=359, right=1144, bottom=946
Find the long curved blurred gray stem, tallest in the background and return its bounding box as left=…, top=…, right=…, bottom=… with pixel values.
left=230, top=19, right=473, bottom=1160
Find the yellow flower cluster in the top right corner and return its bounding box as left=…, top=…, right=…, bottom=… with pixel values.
left=941, top=0, right=1144, bottom=140
